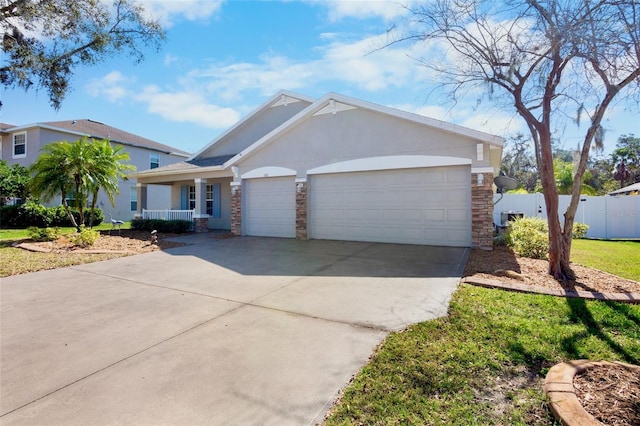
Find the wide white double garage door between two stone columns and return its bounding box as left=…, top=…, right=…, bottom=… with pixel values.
left=308, top=166, right=471, bottom=247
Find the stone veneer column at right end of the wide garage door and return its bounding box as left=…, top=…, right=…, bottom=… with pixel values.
left=471, top=173, right=493, bottom=250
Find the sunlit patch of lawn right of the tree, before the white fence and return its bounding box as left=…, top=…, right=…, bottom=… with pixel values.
left=571, top=240, right=640, bottom=281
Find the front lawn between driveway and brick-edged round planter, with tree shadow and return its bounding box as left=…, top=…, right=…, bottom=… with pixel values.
left=326, top=285, right=640, bottom=425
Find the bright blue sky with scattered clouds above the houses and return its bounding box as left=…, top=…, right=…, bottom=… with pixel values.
left=0, top=0, right=640, bottom=156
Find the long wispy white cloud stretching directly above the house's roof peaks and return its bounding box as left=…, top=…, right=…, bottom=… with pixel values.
left=186, top=31, right=424, bottom=101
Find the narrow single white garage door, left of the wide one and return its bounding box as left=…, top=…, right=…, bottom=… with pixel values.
left=242, top=176, right=296, bottom=238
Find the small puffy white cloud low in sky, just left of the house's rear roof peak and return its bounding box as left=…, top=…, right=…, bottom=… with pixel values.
left=135, top=86, right=240, bottom=129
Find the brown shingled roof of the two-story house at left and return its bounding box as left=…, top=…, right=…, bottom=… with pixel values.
left=4, top=119, right=190, bottom=157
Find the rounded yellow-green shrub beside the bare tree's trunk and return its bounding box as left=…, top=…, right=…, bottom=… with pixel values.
left=505, top=217, right=549, bottom=259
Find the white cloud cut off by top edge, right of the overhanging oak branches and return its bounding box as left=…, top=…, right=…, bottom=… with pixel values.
left=136, top=0, right=224, bottom=27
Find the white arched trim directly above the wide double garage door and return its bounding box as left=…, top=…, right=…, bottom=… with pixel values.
left=307, top=155, right=471, bottom=175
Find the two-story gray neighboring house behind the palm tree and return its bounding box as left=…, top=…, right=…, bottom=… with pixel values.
left=0, top=119, right=189, bottom=220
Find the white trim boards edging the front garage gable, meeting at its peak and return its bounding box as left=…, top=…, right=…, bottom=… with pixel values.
left=224, top=93, right=504, bottom=168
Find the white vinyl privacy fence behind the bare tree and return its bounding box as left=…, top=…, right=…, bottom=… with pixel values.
left=493, top=194, right=640, bottom=239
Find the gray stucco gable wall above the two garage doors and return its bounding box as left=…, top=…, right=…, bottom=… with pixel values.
left=239, top=109, right=491, bottom=177
